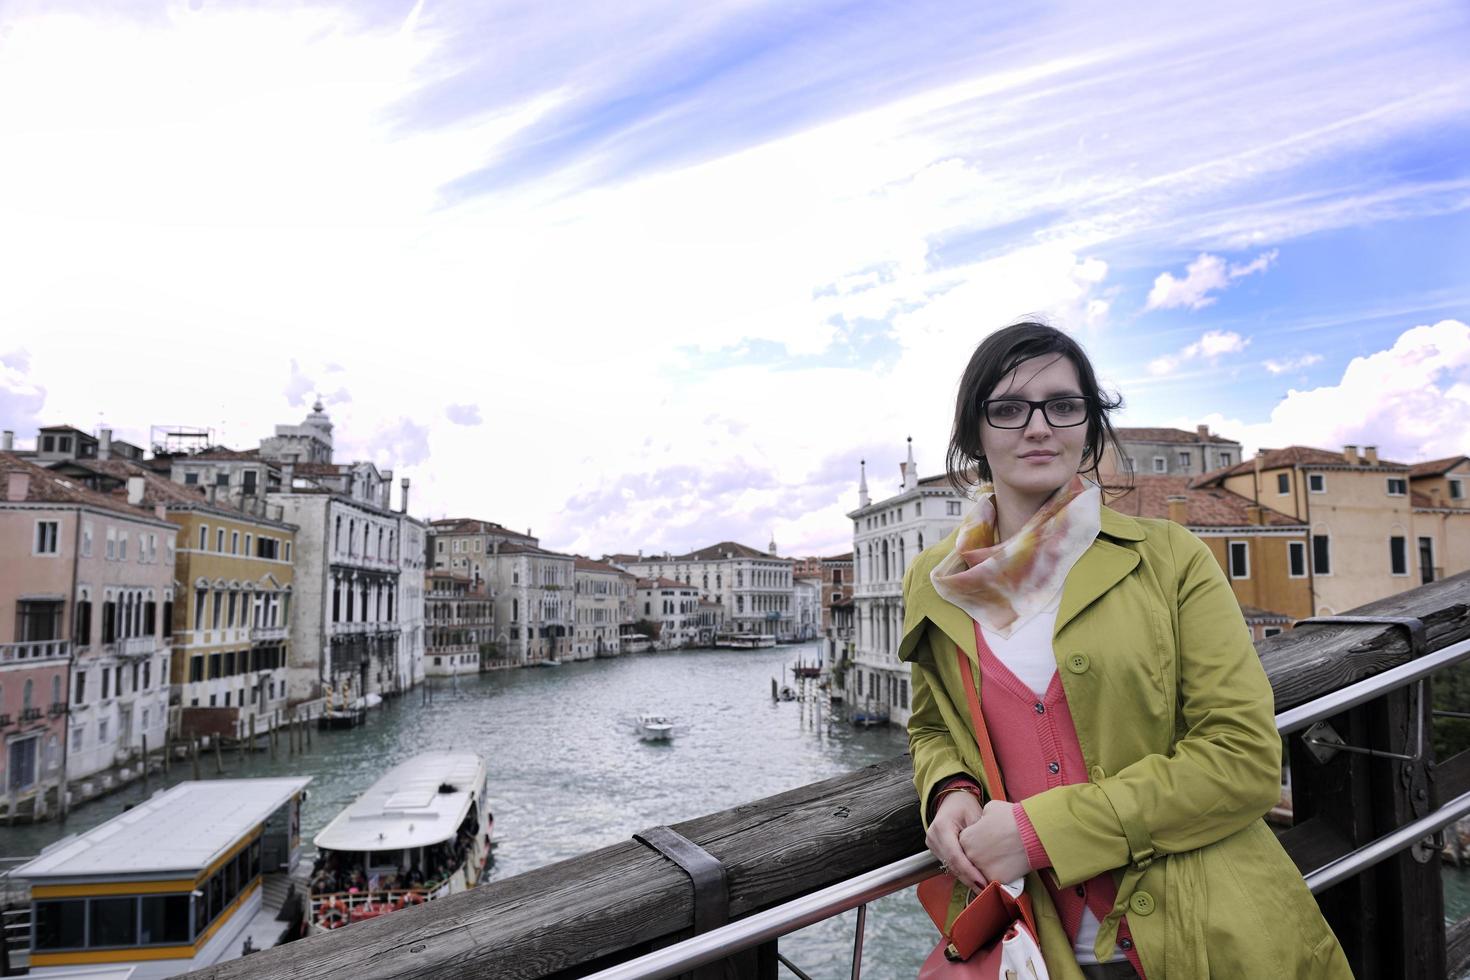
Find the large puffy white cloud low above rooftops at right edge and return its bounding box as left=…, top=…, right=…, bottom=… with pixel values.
left=1188, top=320, right=1470, bottom=463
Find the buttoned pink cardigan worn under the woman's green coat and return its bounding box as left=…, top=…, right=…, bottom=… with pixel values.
left=975, top=623, right=1144, bottom=977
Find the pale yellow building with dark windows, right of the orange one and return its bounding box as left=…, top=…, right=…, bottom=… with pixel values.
left=1195, top=445, right=1420, bottom=616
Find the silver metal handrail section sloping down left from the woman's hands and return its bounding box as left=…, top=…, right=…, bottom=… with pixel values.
left=587, top=851, right=939, bottom=980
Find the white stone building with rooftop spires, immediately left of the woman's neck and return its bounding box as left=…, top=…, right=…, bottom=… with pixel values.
left=844, top=441, right=969, bottom=724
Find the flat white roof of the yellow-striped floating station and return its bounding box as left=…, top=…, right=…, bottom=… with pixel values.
left=12, top=776, right=312, bottom=884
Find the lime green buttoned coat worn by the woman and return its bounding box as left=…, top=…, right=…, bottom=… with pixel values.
left=898, top=507, right=1352, bottom=980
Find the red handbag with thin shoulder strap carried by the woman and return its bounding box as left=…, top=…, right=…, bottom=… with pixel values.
left=919, top=646, right=1047, bottom=980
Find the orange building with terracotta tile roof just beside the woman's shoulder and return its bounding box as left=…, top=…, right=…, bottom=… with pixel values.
left=1108, top=475, right=1313, bottom=639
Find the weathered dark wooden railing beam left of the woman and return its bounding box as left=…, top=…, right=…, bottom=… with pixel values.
left=180, top=755, right=923, bottom=980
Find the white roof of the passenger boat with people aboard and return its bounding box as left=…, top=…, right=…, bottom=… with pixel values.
left=312, top=752, right=485, bottom=851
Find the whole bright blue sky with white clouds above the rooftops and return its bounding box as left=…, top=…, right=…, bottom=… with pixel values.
left=0, top=0, right=1470, bottom=554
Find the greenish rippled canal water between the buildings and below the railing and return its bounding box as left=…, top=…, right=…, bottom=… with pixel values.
left=0, top=645, right=936, bottom=980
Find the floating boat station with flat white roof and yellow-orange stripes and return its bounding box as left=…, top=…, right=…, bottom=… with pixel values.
left=12, top=777, right=312, bottom=980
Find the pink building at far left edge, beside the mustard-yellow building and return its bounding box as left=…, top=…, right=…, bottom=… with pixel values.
left=0, top=453, right=175, bottom=820
